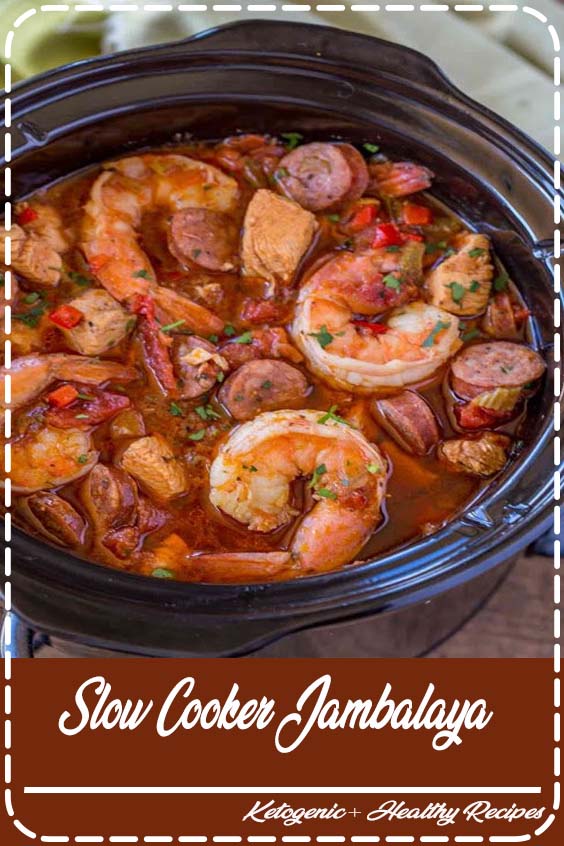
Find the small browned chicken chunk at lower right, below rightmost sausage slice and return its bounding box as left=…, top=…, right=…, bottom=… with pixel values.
left=438, top=432, right=511, bottom=476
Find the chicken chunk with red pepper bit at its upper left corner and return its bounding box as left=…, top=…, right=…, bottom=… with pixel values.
left=61, top=288, right=131, bottom=355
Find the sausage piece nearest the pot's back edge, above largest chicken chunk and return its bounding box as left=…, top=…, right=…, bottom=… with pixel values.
left=277, top=141, right=362, bottom=211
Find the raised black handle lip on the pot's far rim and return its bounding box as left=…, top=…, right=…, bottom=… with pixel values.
left=181, top=20, right=463, bottom=97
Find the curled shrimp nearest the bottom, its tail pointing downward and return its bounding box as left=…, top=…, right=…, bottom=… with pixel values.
left=207, top=411, right=386, bottom=572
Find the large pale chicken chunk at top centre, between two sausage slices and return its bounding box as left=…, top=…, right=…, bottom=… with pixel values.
left=241, top=188, right=317, bottom=283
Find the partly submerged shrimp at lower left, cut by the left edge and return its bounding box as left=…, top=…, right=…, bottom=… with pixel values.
left=6, top=426, right=98, bottom=493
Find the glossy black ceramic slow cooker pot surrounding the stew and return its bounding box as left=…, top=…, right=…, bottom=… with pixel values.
left=2, top=21, right=554, bottom=656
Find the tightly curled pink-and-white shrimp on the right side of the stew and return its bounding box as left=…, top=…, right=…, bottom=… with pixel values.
left=292, top=250, right=461, bottom=393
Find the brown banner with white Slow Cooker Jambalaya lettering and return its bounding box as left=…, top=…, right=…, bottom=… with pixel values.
left=0, top=659, right=563, bottom=846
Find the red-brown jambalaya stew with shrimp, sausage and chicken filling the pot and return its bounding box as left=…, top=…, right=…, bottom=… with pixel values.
left=0, top=137, right=545, bottom=582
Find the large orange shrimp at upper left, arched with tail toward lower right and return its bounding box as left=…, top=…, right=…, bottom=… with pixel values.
left=82, top=153, right=239, bottom=334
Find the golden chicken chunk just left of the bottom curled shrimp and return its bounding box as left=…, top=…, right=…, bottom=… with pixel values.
left=121, top=435, right=188, bottom=502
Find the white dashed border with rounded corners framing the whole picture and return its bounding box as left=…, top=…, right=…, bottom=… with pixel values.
left=4, top=3, right=561, bottom=844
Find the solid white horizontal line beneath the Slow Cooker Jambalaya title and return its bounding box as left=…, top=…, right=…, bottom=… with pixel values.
left=24, top=785, right=541, bottom=794
